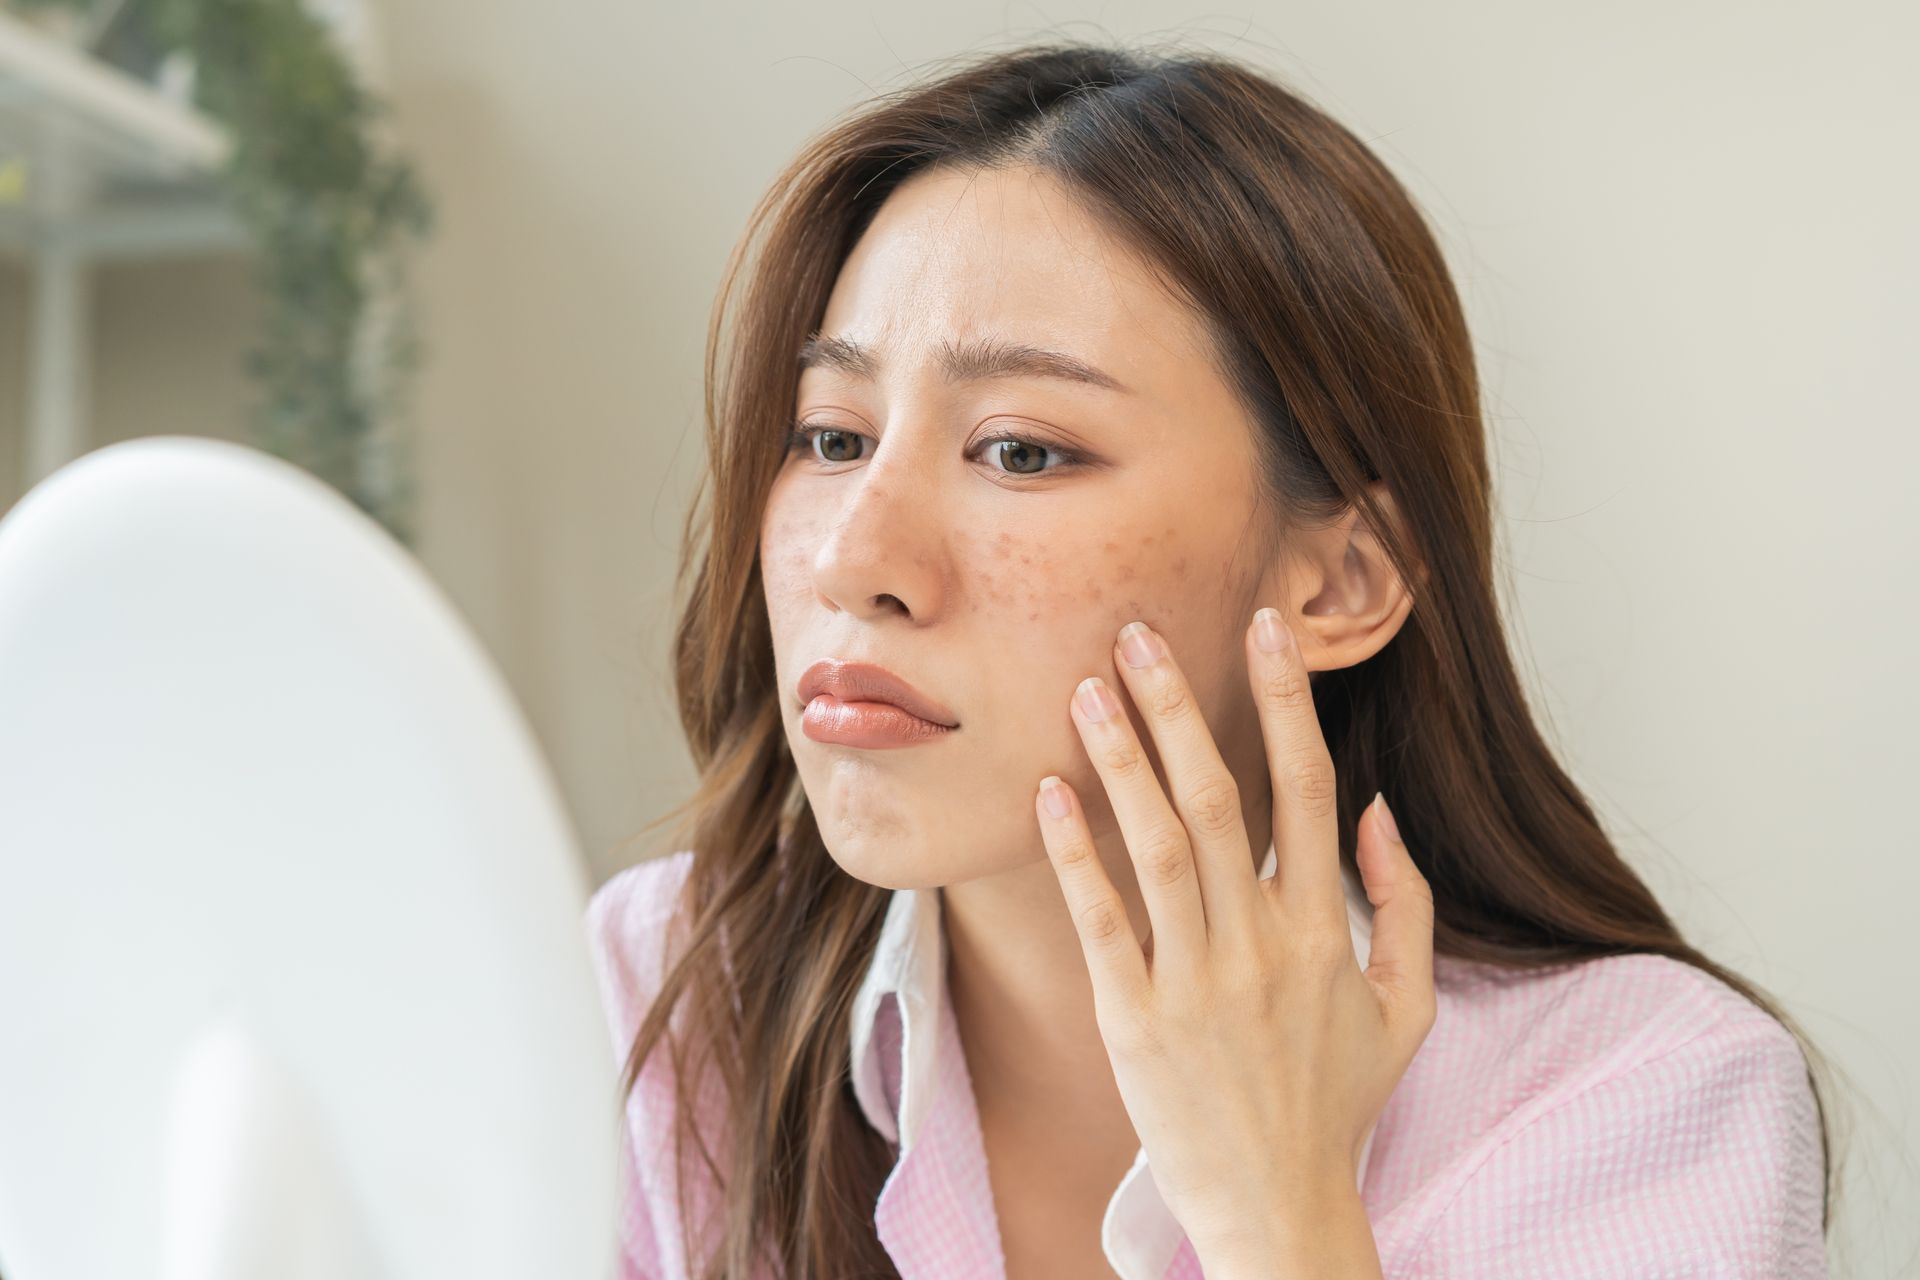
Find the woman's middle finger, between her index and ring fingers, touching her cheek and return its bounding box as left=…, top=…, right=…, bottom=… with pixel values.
left=1114, top=622, right=1260, bottom=938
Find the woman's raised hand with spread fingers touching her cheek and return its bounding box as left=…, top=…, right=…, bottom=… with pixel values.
left=1035, top=608, right=1434, bottom=1274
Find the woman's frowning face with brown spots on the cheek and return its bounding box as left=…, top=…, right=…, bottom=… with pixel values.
left=760, top=169, right=1288, bottom=889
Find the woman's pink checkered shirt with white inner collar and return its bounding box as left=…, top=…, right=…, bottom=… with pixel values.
left=588, top=846, right=1828, bottom=1280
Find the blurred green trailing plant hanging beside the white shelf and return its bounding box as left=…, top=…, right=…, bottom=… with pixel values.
left=15, top=0, right=432, bottom=545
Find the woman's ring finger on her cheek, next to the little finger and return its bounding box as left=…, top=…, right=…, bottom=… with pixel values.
left=1073, top=676, right=1206, bottom=963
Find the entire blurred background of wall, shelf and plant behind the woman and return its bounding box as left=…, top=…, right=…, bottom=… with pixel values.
left=0, top=0, right=1920, bottom=1276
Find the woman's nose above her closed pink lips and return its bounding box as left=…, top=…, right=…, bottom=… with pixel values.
left=814, top=430, right=947, bottom=622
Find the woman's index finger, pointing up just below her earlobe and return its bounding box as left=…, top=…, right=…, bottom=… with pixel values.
left=1246, top=608, right=1346, bottom=929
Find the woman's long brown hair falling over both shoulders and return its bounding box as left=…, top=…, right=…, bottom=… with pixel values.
left=622, top=42, right=1834, bottom=1280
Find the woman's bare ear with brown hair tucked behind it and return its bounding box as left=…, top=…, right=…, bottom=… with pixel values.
left=1284, top=482, right=1413, bottom=672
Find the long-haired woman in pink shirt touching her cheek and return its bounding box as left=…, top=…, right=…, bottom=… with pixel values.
left=589, top=44, right=1828, bottom=1280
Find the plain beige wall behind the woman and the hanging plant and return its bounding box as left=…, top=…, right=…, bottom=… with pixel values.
left=0, top=0, right=1920, bottom=1276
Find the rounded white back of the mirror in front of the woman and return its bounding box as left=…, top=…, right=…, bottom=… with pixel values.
left=0, top=436, right=620, bottom=1280
